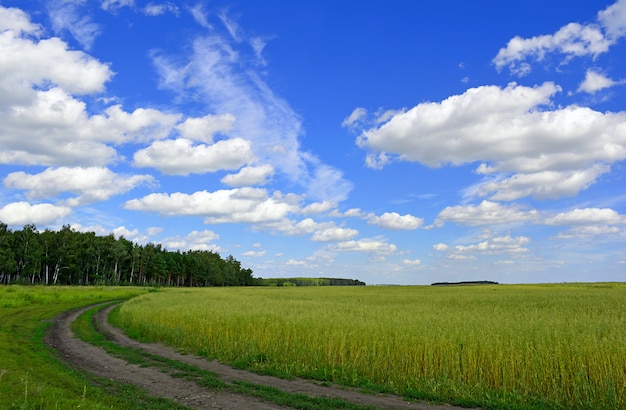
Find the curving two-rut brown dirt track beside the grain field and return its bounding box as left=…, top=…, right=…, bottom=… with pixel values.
left=46, top=306, right=472, bottom=410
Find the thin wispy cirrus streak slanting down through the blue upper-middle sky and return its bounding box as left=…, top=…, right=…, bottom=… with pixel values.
left=153, top=7, right=352, bottom=201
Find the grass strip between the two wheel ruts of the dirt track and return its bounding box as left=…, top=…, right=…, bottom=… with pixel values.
left=72, top=304, right=375, bottom=410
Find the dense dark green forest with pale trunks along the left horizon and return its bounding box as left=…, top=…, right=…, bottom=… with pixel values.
left=0, top=222, right=262, bottom=286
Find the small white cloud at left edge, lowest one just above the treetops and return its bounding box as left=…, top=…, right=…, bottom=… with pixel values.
left=0, top=202, right=72, bottom=226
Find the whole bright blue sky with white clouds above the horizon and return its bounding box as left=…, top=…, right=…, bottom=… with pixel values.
left=0, top=0, right=626, bottom=284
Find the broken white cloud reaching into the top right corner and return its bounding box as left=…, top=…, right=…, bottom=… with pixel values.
left=493, top=0, right=626, bottom=76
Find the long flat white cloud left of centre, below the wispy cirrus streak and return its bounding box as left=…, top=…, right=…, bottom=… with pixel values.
left=124, top=188, right=295, bottom=223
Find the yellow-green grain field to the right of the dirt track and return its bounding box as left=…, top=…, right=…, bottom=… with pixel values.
left=118, top=284, right=626, bottom=409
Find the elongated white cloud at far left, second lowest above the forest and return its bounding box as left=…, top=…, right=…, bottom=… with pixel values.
left=4, top=167, right=154, bottom=206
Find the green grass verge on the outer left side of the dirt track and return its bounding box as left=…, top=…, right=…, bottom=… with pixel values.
left=0, top=285, right=184, bottom=410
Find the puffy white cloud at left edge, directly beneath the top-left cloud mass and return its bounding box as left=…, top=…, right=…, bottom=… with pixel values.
left=0, top=88, right=179, bottom=166
